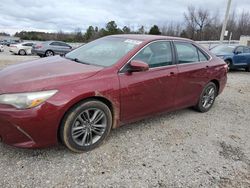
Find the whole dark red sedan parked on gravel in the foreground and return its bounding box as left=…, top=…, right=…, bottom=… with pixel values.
left=0, top=35, right=227, bottom=152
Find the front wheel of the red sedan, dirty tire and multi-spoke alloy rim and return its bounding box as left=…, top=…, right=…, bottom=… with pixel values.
left=59, top=100, right=112, bottom=153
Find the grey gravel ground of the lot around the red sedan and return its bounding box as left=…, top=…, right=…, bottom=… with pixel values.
left=0, top=46, right=250, bottom=187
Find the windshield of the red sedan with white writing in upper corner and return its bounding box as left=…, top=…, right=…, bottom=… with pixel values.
left=65, top=37, right=142, bottom=67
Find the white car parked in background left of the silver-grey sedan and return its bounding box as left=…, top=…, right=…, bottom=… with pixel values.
left=9, top=42, right=34, bottom=55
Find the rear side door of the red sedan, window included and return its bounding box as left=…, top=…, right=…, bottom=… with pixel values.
left=174, top=41, right=210, bottom=108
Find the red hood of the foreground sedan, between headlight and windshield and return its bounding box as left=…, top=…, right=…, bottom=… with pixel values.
left=0, top=56, right=103, bottom=94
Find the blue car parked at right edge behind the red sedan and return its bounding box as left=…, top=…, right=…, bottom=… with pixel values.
left=210, top=44, right=250, bottom=72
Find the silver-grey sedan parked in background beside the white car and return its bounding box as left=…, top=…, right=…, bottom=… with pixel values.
left=31, top=41, right=72, bottom=57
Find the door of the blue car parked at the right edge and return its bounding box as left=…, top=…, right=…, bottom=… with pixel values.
left=233, top=46, right=247, bottom=67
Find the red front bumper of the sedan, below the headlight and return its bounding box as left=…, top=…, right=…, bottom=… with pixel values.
left=0, top=103, right=61, bottom=148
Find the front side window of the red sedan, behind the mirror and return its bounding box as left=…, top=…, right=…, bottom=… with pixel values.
left=133, top=41, right=173, bottom=68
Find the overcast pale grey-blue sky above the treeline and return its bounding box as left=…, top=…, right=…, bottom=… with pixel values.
left=0, top=0, right=250, bottom=34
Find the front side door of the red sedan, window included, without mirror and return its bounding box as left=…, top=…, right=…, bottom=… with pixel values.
left=119, top=41, right=177, bottom=122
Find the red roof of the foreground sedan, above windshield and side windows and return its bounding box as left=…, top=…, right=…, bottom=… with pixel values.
left=108, top=34, right=192, bottom=42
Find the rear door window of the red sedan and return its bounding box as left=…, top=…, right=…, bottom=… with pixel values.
left=175, top=42, right=199, bottom=63
